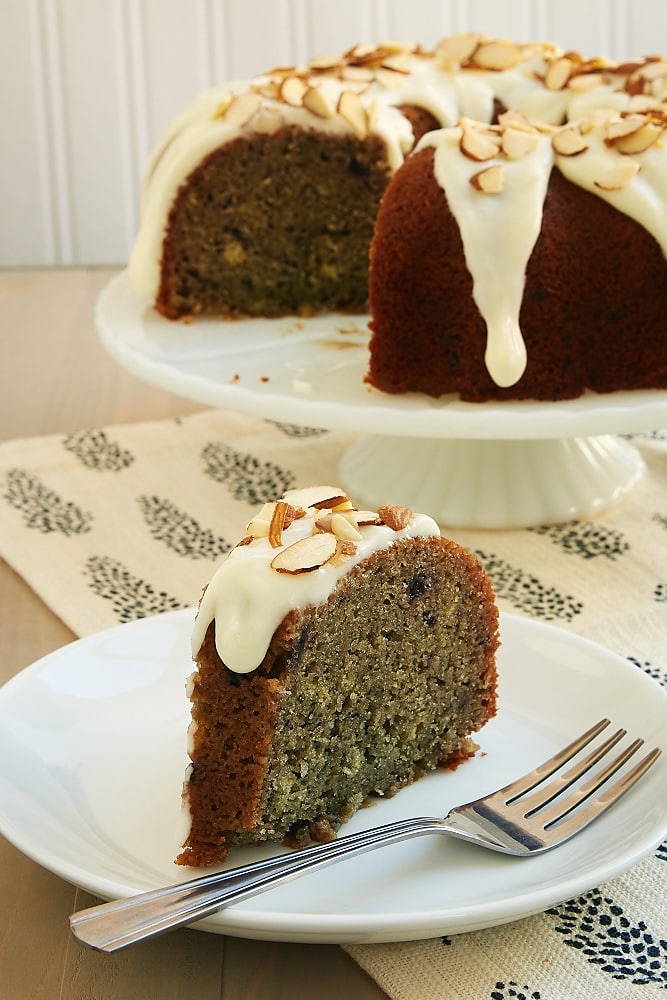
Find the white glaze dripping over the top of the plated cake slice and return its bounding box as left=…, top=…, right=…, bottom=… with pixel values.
left=192, top=487, right=440, bottom=673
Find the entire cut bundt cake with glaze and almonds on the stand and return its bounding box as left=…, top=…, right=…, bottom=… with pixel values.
left=129, top=34, right=667, bottom=401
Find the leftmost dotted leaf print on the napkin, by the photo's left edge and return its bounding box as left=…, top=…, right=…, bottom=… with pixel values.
left=3, top=469, right=93, bottom=536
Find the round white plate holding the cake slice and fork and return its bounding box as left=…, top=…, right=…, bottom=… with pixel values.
left=0, top=610, right=667, bottom=942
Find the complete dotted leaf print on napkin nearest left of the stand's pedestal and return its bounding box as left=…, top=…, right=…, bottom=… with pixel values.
left=202, top=441, right=295, bottom=506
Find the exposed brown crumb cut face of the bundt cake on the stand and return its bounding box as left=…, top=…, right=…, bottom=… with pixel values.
left=156, top=127, right=389, bottom=319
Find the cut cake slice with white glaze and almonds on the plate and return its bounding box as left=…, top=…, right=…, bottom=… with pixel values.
left=177, top=486, right=498, bottom=867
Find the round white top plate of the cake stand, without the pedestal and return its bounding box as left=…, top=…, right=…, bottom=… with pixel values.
left=96, top=272, right=667, bottom=440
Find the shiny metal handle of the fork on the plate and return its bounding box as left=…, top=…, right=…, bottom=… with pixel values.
left=70, top=817, right=446, bottom=952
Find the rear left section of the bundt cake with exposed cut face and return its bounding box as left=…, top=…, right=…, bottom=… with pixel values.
left=129, top=35, right=667, bottom=319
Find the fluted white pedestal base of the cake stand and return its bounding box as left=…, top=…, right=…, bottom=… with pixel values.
left=340, top=435, right=644, bottom=528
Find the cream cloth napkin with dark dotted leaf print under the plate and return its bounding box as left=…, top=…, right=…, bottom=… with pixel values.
left=0, top=411, right=667, bottom=1000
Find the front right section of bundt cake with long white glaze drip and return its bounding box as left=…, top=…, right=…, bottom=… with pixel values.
left=368, top=110, right=667, bottom=402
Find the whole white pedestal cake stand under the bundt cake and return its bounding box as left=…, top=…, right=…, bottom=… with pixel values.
left=96, top=272, right=667, bottom=528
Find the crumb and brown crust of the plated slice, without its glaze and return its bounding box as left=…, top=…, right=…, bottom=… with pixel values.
left=178, top=537, right=498, bottom=866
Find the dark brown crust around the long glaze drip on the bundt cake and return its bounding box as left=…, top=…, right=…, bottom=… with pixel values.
left=368, top=148, right=667, bottom=402
